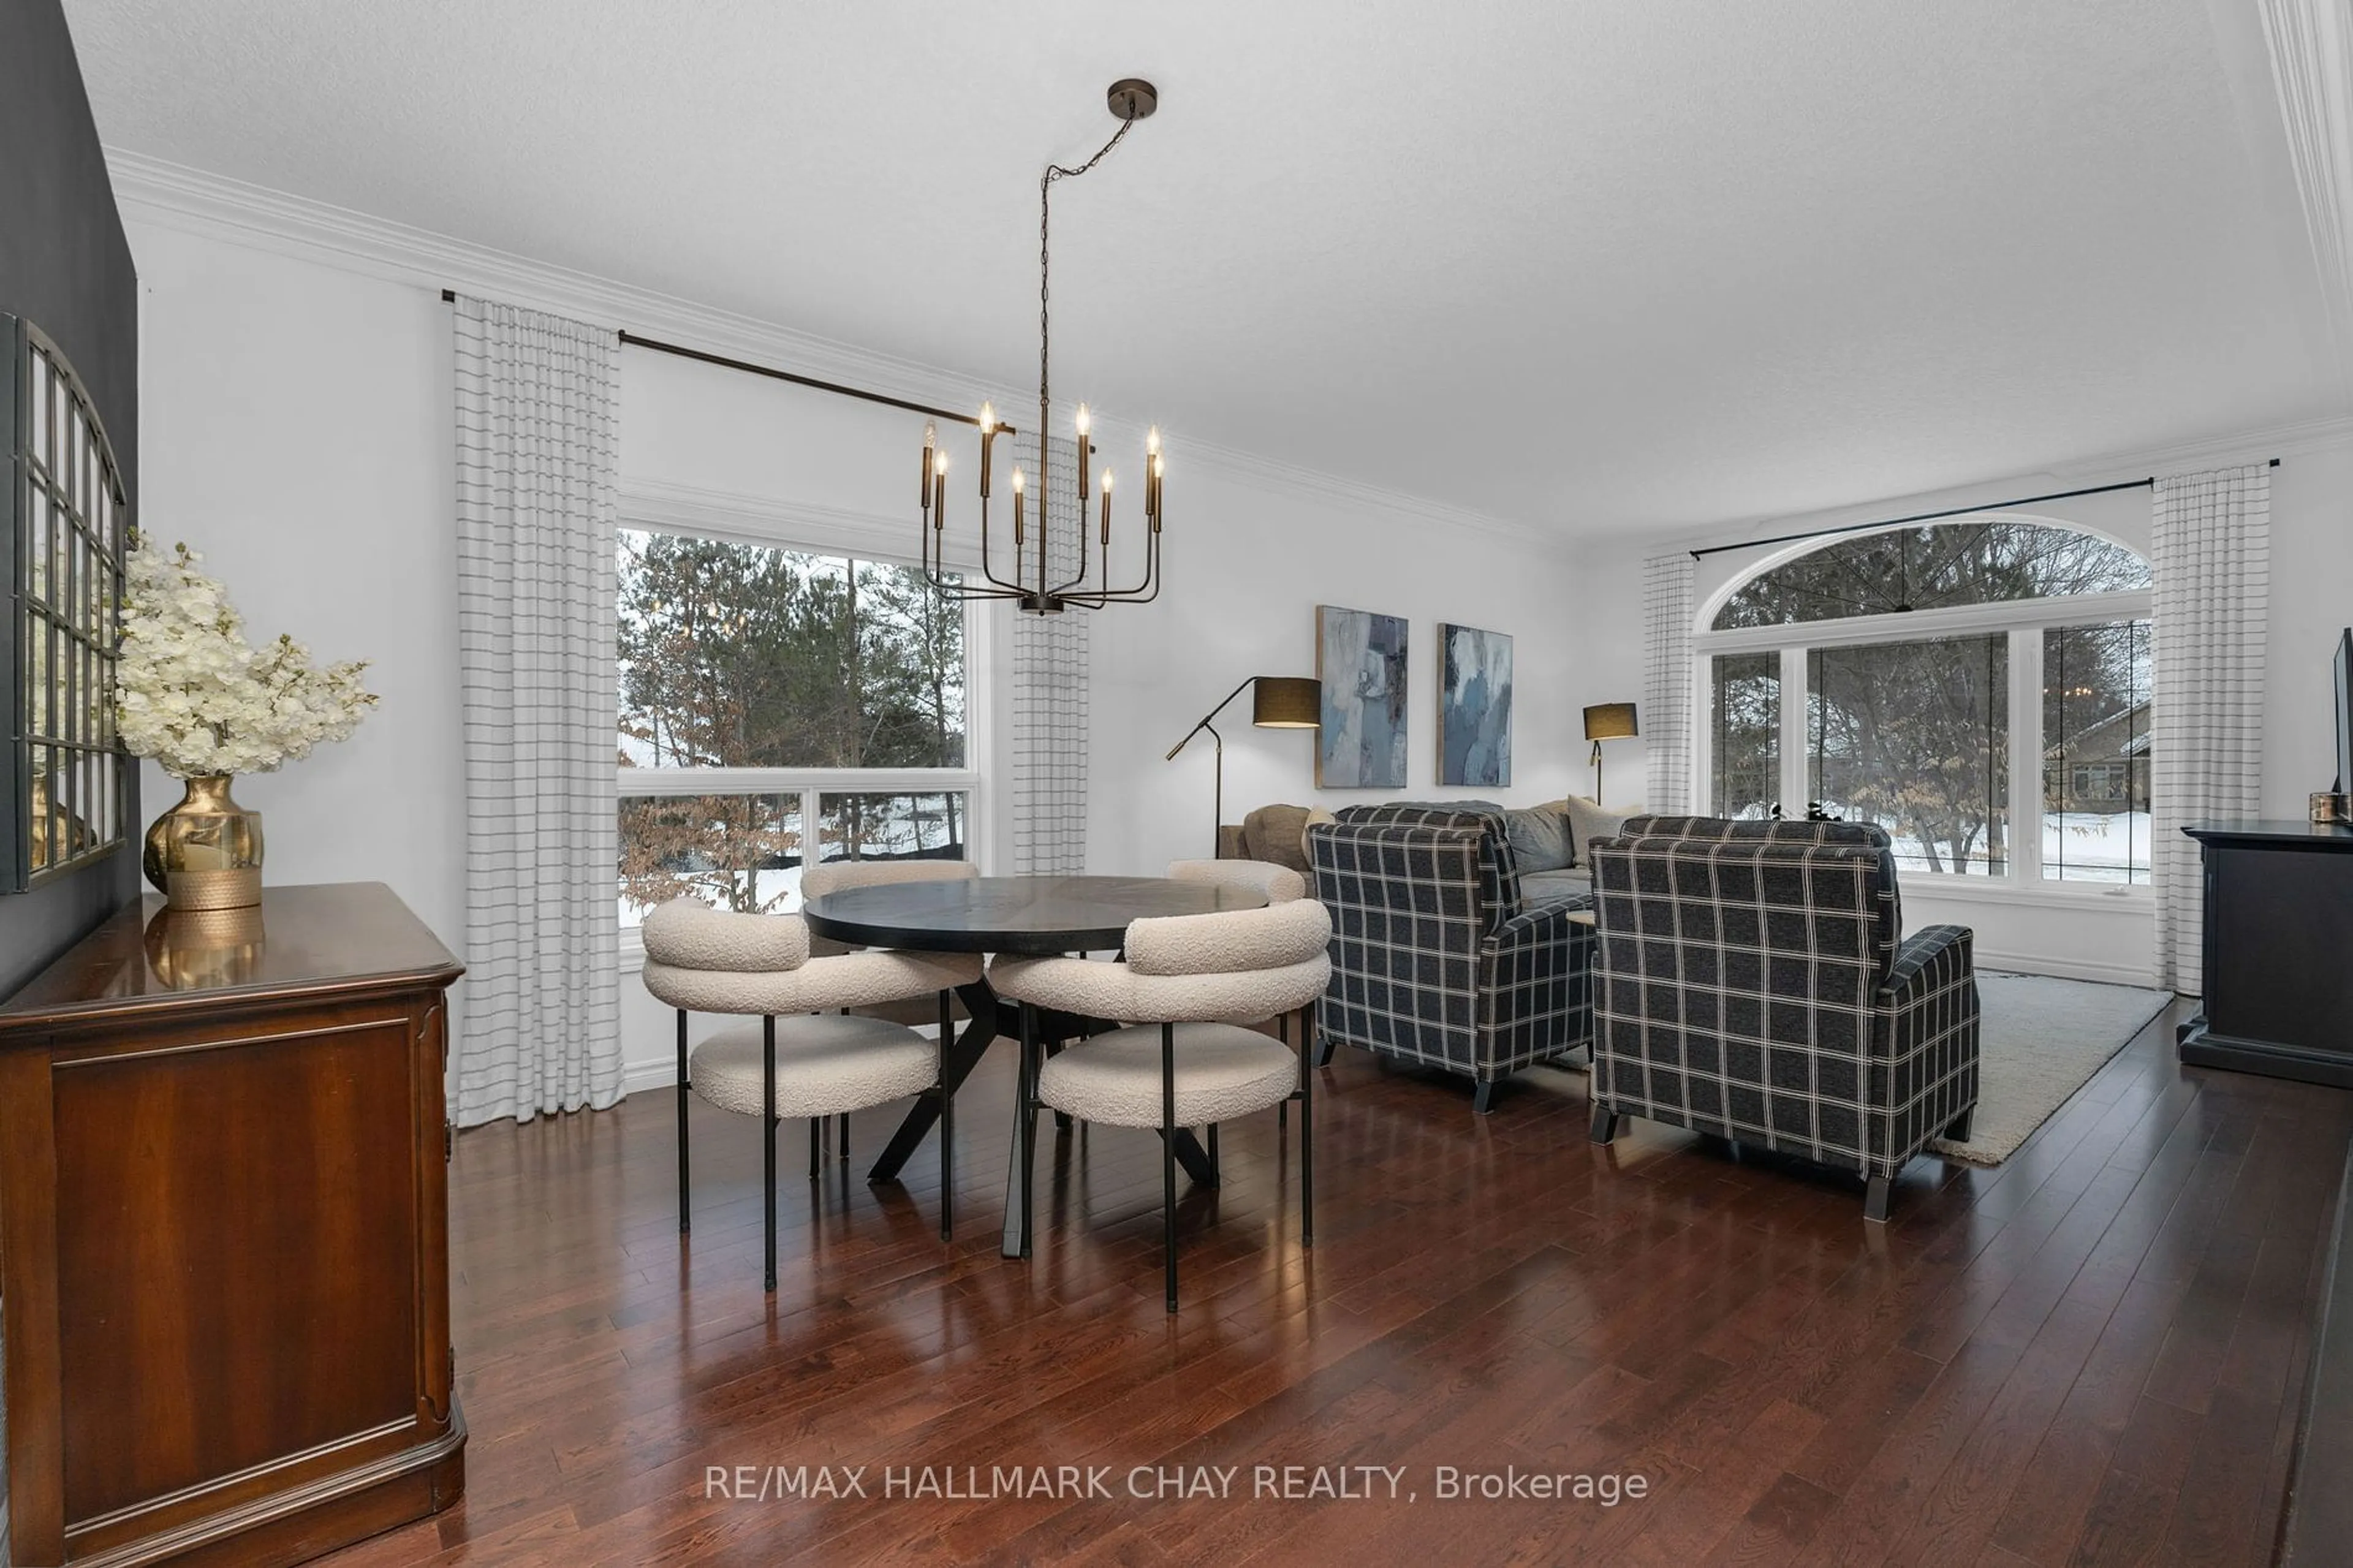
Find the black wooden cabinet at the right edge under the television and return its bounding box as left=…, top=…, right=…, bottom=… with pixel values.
left=2179, top=822, right=2353, bottom=1088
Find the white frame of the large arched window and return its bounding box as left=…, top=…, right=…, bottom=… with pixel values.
left=1692, top=513, right=2155, bottom=906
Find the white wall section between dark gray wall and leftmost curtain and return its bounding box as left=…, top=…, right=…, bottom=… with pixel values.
left=129, top=221, right=466, bottom=951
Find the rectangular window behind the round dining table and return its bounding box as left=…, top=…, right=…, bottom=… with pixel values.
left=619, top=528, right=979, bottom=925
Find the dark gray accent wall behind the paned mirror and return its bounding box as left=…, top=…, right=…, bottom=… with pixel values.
left=0, top=0, right=143, bottom=996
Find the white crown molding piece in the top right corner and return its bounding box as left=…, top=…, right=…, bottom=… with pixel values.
left=2257, top=0, right=2353, bottom=381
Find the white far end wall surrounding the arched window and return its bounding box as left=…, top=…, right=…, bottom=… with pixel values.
left=1583, top=442, right=2353, bottom=984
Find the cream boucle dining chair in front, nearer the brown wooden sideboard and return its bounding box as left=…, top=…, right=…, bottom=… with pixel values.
left=645, top=900, right=981, bottom=1290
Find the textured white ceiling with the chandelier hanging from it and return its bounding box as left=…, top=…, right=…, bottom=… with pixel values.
left=66, top=0, right=2346, bottom=534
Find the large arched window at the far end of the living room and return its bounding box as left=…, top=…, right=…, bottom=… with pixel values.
left=1694, top=518, right=2151, bottom=885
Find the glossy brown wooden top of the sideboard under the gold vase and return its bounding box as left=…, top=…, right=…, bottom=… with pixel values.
left=0, top=883, right=466, bottom=1043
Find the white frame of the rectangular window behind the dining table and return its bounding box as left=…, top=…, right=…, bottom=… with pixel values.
left=614, top=506, right=998, bottom=970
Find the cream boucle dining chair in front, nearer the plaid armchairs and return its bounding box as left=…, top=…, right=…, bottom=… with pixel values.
left=988, top=900, right=1332, bottom=1311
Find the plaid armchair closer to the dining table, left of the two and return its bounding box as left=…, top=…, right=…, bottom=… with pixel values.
left=1308, top=805, right=1593, bottom=1113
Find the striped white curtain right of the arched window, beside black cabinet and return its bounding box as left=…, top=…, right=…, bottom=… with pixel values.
left=2148, top=464, right=2271, bottom=996
